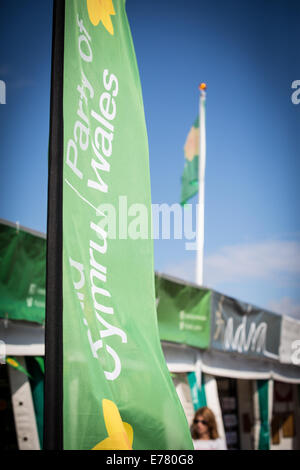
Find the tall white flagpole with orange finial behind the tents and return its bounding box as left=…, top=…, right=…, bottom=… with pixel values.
left=196, top=83, right=206, bottom=286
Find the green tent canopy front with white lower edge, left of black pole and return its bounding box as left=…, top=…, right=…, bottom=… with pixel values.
left=0, top=220, right=46, bottom=356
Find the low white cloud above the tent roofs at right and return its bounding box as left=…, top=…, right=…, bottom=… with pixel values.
left=164, top=241, right=300, bottom=320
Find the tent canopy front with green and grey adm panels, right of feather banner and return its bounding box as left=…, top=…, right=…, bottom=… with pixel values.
left=156, top=274, right=300, bottom=383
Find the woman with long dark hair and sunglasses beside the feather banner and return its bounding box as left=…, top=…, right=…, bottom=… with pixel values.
left=191, top=406, right=227, bottom=450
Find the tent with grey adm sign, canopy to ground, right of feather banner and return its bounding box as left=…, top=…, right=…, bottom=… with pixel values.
left=155, top=274, right=300, bottom=450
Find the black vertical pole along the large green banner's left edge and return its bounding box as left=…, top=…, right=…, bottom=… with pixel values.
left=43, top=0, right=65, bottom=450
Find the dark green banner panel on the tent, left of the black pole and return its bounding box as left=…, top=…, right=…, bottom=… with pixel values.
left=0, top=221, right=46, bottom=323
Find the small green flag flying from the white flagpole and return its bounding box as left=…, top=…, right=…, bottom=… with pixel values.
left=181, top=118, right=199, bottom=205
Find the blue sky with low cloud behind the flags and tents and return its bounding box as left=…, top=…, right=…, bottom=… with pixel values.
left=0, top=0, right=300, bottom=318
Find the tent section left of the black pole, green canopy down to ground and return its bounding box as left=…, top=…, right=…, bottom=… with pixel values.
left=0, top=220, right=46, bottom=450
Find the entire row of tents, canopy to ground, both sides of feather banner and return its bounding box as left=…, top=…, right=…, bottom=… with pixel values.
left=0, top=220, right=300, bottom=449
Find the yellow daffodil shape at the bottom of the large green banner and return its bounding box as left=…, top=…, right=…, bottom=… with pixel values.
left=92, top=399, right=133, bottom=450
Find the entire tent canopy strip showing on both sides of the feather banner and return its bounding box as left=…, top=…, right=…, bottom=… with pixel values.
left=0, top=220, right=300, bottom=383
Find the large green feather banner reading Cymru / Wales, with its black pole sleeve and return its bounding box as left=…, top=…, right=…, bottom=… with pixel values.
left=45, top=0, right=193, bottom=449
